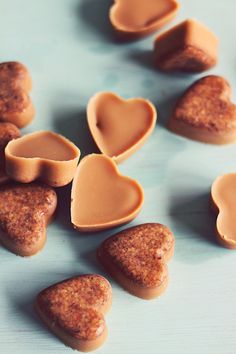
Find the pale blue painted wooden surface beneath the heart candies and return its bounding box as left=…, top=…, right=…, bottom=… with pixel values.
left=0, top=0, right=236, bottom=354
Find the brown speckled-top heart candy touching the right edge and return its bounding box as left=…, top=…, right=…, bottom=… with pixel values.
left=169, top=75, right=236, bottom=144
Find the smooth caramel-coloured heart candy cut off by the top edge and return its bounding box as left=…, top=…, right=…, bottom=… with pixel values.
left=110, top=0, right=179, bottom=39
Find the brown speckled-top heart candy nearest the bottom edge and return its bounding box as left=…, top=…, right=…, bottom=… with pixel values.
left=36, top=274, right=112, bottom=352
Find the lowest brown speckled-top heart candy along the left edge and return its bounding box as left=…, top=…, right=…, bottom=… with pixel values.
left=0, top=183, right=57, bottom=256
